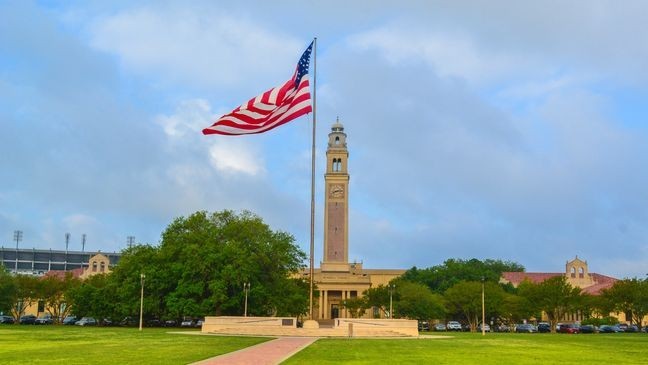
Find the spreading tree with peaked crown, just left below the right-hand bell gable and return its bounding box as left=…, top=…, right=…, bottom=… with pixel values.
left=518, top=275, right=581, bottom=332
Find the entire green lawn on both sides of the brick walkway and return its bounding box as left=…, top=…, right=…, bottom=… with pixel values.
left=0, top=325, right=648, bottom=365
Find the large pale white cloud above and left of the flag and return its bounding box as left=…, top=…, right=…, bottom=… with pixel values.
left=90, top=3, right=304, bottom=86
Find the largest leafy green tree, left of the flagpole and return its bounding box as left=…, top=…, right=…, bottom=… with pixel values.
left=106, top=210, right=309, bottom=318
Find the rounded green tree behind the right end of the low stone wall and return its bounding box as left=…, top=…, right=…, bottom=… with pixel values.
left=396, top=280, right=445, bottom=321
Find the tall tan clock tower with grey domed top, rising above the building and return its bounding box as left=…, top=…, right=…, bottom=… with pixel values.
left=322, top=119, right=349, bottom=271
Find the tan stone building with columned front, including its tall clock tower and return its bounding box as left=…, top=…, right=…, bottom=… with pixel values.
left=302, top=120, right=406, bottom=320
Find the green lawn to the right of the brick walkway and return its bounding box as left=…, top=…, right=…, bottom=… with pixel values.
left=282, top=333, right=648, bottom=365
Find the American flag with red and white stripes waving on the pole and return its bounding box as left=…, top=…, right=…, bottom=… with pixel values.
left=203, top=42, right=313, bottom=135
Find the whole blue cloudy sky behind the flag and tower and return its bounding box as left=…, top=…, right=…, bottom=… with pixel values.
left=0, top=1, right=648, bottom=277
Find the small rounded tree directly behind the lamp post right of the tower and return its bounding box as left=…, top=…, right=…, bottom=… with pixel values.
left=443, top=281, right=504, bottom=332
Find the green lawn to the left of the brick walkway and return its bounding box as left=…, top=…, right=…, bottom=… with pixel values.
left=0, top=325, right=268, bottom=364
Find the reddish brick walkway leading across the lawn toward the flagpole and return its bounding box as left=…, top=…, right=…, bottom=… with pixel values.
left=193, top=337, right=317, bottom=365
